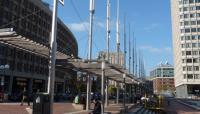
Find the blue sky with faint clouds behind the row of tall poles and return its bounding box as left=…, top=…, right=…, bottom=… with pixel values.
left=43, top=0, right=173, bottom=76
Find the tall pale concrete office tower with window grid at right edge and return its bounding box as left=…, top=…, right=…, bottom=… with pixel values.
left=171, top=0, right=200, bottom=98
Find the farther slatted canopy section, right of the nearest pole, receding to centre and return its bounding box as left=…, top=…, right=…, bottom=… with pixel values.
left=56, top=59, right=137, bottom=84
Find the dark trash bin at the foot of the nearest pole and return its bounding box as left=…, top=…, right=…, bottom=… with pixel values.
left=32, top=93, right=50, bottom=114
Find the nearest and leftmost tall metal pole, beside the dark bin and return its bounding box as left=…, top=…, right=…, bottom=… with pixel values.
left=47, top=0, right=58, bottom=114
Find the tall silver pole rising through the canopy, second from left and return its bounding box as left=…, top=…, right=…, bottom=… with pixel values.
left=86, top=0, right=94, bottom=110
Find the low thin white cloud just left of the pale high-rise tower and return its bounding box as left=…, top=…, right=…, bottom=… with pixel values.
left=140, top=46, right=172, bottom=53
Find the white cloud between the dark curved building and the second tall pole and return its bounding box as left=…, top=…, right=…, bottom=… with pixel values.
left=67, top=22, right=89, bottom=32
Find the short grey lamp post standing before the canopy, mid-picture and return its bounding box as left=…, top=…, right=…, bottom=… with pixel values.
left=101, top=61, right=105, bottom=114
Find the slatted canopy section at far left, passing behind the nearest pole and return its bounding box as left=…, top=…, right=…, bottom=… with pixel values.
left=0, top=28, right=68, bottom=59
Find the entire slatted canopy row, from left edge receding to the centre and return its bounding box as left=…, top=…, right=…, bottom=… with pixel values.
left=0, top=28, right=138, bottom=84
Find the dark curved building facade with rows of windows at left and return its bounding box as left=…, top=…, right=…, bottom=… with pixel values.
left=0, top=0, right=78, bottom=99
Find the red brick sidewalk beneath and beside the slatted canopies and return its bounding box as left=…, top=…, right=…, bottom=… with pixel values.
left=0, top=103, right=134, bottom=114
